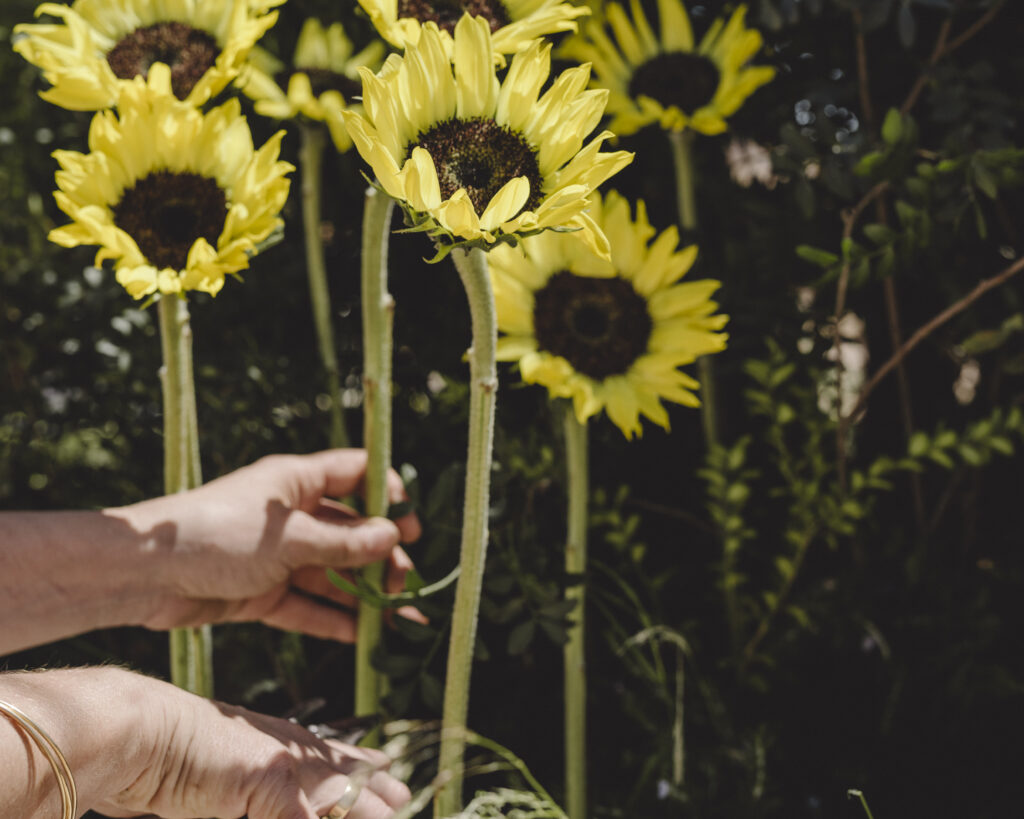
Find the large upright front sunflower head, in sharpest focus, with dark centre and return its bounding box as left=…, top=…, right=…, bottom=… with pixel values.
left=342, top=14, right=633, bottom=255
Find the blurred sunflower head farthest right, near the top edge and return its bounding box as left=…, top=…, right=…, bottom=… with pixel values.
left=561, top=0, right=775, bottom=135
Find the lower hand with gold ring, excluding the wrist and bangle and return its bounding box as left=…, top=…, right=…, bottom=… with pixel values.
left=102, top=680, right=410, bottom=819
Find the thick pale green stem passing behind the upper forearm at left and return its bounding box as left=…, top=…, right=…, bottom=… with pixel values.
left=158, top=296, right=213, bottom=697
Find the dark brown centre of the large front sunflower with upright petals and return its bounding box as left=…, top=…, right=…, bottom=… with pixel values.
left=409, top=118, right=544, bottom=214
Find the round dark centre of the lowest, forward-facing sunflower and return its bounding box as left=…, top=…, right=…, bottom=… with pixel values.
left=534, top=270, right=653, bottom=381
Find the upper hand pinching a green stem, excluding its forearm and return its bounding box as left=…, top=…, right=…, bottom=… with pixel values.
left=118, top=449, right=420, bottom=642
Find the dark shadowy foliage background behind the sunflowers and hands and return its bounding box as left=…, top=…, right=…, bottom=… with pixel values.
left=0, top=0, right=1024, bottom=819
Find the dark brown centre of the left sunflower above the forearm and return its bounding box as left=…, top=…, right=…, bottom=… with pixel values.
left=113, top=171, right=227, bottom=270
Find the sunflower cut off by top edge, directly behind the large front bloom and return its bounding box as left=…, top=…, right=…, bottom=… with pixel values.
left=359, top=0, right=590, bottom=62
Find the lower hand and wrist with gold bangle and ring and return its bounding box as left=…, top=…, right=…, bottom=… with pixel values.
left=0, top=667, right=410, bottom=819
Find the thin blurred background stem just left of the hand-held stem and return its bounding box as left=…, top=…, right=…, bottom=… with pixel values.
left=299, top=125, right=348, bottom=446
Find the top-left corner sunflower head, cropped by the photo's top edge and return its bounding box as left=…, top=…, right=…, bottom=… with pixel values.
left=13, top=0, right=279, bottom=111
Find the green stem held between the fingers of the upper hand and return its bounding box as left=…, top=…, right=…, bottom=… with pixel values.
left=355, top=187, right=394, bottom=724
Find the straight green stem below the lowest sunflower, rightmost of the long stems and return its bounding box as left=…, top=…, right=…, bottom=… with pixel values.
left=563, top=403, right=589, bottom=819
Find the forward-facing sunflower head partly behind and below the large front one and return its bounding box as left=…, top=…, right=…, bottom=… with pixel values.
left=490, top=191, right=728, bottom=438
